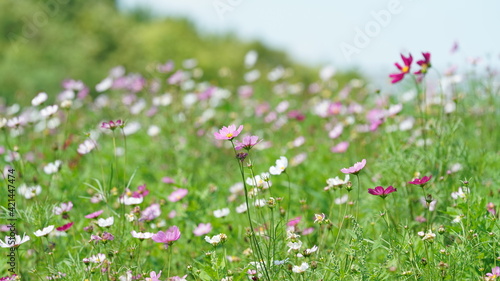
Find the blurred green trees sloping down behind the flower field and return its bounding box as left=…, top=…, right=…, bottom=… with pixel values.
left=0, top=0, right=360, bottom=103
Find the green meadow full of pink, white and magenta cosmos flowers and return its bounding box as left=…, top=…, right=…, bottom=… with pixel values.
left=0, top=51, right=500, bottom=281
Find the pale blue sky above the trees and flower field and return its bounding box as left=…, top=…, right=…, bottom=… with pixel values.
left=119, top=0, right=500, bottom=79
